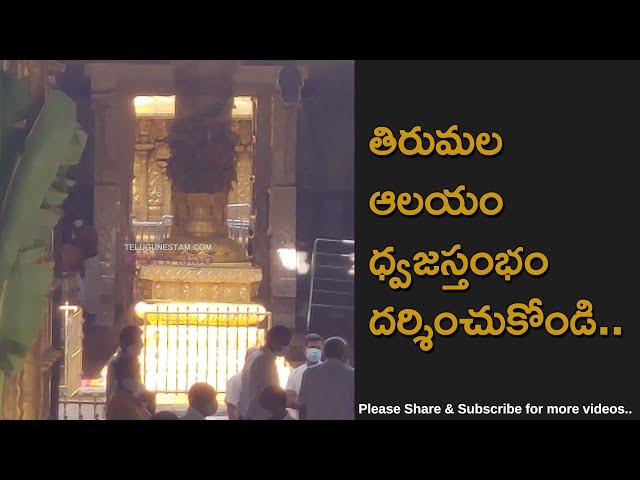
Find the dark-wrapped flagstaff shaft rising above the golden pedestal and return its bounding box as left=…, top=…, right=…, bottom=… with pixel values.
left=168, top=61, right=247, bottom=263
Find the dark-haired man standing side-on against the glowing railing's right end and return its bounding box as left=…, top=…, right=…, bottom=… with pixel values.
left=238, top=325, right=292, bottom=420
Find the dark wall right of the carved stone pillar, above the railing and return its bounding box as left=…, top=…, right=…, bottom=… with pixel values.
left=296, top=61, right=354, bottom=329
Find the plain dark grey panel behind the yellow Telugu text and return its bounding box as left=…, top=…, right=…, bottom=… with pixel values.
left=355, top=60, right=640, bottom=419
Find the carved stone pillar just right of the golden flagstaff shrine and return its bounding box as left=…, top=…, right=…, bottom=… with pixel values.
left=234, top=62, right=307, bottom=327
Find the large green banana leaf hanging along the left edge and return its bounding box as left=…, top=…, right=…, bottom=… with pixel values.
left=0, top=85, right=87, bottom=411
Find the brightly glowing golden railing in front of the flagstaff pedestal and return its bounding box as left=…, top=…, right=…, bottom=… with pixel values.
left=141, top=303, right=271, bottom=395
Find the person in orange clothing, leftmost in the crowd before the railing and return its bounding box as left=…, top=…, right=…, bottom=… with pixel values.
left=107, top=325, right=155, bottom=420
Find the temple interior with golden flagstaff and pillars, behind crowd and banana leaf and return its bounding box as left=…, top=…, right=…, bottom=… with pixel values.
left=0, top=60, right=354, bottom=418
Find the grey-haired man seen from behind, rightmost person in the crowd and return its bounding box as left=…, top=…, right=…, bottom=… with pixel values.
left=298, top=337, right=355, bottom=420
